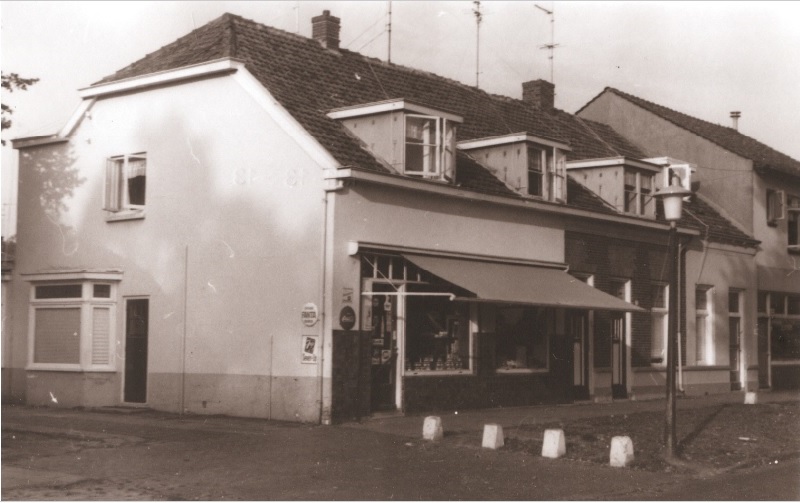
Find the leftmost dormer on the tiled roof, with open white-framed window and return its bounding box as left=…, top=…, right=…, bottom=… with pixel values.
left=328, top=99, right=464, bottom=182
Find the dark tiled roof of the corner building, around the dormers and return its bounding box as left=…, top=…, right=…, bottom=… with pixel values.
left=95, top=14, right=756, bottom=248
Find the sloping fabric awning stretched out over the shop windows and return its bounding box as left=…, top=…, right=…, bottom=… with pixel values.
left=403, top=254, right=644, bottom=311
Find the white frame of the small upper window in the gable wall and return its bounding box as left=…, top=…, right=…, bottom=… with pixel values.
left=103, top=152, right=149, bottom=220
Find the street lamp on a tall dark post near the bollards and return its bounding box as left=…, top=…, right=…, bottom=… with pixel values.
left=653, top=183, right=691, bottom=460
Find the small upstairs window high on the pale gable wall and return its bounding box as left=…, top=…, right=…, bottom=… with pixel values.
left=104, top=153, right=147, bottom=213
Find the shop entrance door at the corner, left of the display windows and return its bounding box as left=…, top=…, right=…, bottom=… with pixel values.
left=370, top=284, right=400, bottom=412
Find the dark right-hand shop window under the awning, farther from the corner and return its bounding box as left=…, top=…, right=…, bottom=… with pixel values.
left=495, top=307, right=555, bottom=373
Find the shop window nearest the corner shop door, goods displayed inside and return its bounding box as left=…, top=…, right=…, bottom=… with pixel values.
left=404, top=292, right=472, bottom=375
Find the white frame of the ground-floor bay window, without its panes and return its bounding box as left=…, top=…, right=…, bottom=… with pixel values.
left=26, top=279, right=117, bottom=372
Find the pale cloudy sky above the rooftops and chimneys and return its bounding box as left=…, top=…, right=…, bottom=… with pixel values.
left=0, top=0, right=800, bottom=236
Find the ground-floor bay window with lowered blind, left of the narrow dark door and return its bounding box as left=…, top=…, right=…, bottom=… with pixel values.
left=28, top=281, right=115, bottom=371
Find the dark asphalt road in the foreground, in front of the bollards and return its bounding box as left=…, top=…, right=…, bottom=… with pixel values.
left=1, top=407, right=800, bottom=500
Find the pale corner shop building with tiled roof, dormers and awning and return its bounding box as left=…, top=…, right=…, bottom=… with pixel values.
left=4, top=11, right=755, bottom=423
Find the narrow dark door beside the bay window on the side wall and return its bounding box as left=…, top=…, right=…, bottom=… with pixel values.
left=123, top=299, right=150, bottom=403
